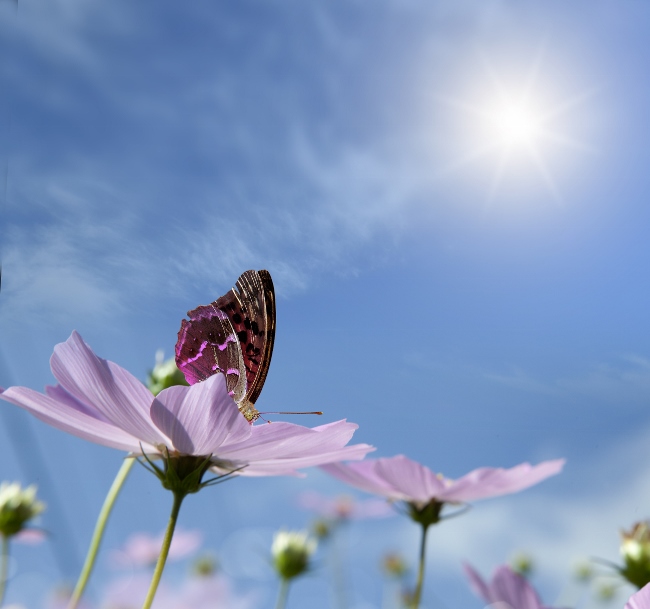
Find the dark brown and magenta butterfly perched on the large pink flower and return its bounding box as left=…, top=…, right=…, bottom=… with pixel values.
left=176, top=271, right=275, bottom=422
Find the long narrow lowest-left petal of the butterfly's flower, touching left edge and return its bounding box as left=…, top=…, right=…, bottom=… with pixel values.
left=0, top=387, right=146, bottom=453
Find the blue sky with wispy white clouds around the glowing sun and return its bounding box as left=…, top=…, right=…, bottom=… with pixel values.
left=0, top=0, right=650, bottom=609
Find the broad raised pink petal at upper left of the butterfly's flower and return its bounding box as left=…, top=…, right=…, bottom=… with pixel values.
left=50, top=331, right=167, bottom=445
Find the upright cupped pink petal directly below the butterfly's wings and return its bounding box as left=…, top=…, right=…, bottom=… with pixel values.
left=151, top=374, right=251, bottom=455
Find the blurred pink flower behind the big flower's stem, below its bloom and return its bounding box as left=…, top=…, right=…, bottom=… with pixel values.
left=113, top=528, right=203, bottom=567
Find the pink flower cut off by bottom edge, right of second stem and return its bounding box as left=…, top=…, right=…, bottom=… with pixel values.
left=463, top=564, right=552, bottom=609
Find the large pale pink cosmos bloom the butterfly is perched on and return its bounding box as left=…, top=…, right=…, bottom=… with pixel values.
left=0, top=332, right=373, bottom=476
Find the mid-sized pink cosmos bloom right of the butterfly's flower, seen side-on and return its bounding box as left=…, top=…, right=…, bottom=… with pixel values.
left=322, top=455, right=564, bottom=509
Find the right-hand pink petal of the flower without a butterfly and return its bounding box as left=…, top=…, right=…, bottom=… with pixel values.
left=438, top=459, right=565, bottom=502
